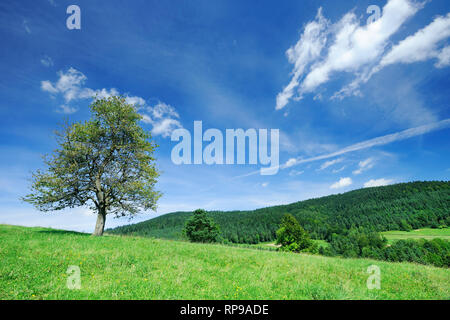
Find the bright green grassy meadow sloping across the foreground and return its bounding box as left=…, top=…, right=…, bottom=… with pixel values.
left=0, top=225, right=450, bottom=299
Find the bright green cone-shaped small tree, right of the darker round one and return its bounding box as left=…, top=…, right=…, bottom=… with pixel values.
left=276, top=214, right=313, bottom=252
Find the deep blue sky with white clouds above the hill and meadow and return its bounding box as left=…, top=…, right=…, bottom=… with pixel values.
left=0, top=0, right=450, bottom=232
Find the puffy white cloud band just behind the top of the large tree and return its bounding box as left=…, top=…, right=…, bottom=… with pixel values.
left=41, top=68, right=182, bottom=137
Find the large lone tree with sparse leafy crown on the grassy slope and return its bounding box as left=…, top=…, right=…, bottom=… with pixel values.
left=23, top=96, right=160, bottom=236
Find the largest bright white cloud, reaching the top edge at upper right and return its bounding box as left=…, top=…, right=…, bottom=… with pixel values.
left=276, top=0, right=422, bottom=110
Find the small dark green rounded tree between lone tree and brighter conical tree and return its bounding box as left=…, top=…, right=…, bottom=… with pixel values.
left=184, top=209, right=219, bottom=242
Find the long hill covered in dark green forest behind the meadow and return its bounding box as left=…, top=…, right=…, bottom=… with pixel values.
left=107, top=181, right=450, bottom=243
